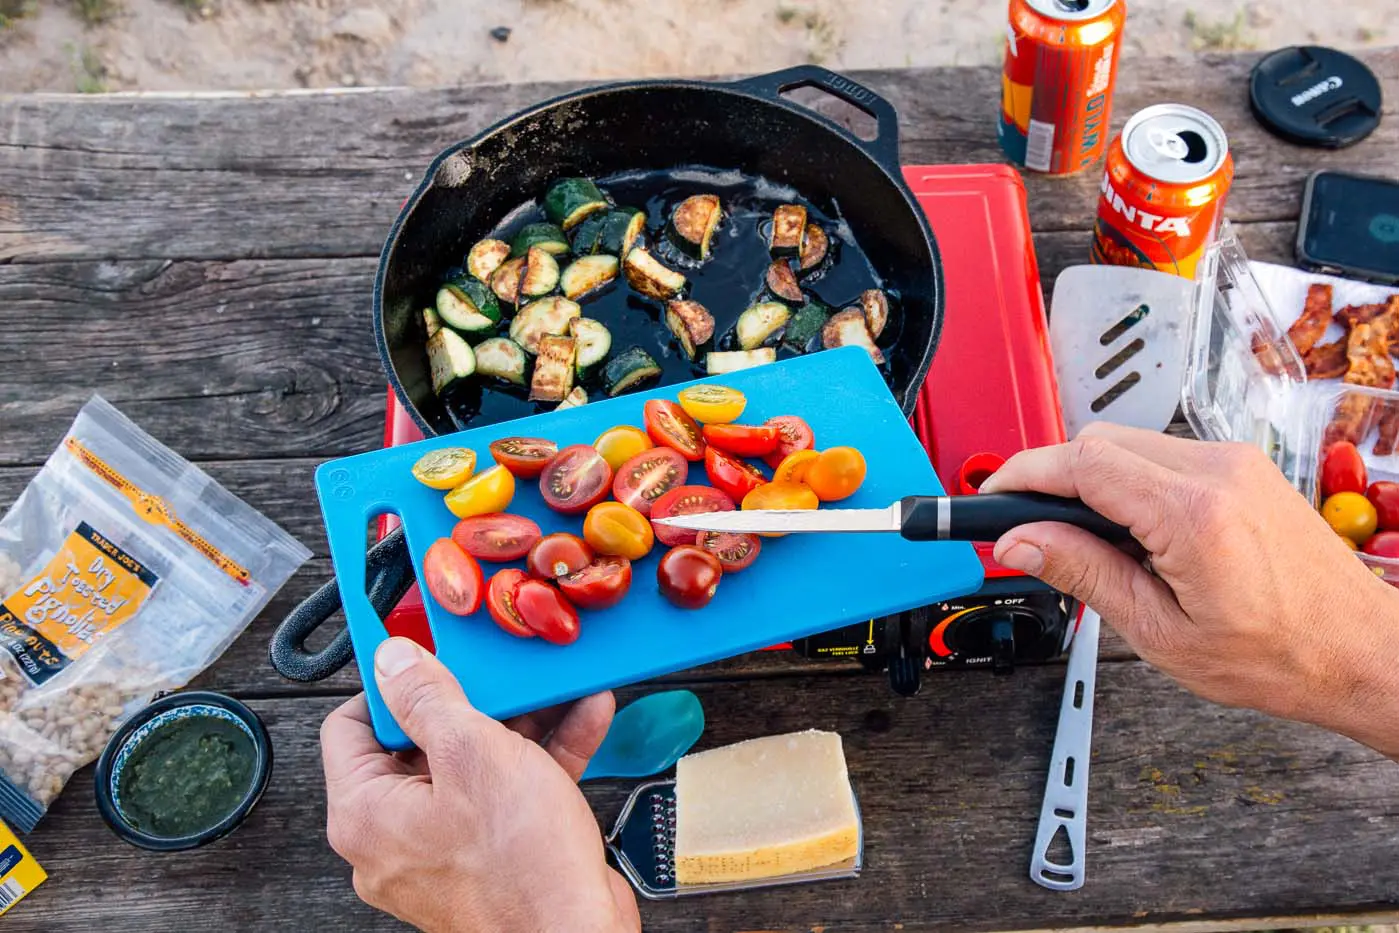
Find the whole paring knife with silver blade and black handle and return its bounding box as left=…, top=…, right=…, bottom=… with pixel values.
left=653, top=492, right=1132, bottom=543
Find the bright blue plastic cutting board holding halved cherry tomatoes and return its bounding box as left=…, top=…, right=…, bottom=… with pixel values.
left=316, top=347, right=982, bottom=750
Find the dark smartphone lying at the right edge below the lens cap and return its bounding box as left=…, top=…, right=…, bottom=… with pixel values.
left=1297, top=171, right=1399, bottom=285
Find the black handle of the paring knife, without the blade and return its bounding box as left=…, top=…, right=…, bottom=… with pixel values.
left=900, top=492, right=1132, bottom=543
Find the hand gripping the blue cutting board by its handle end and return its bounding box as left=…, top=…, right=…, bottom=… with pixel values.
left=320, top=638, right=641, bottom=933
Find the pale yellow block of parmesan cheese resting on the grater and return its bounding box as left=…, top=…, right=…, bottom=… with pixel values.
left=676, top=730, right=860, bottom=884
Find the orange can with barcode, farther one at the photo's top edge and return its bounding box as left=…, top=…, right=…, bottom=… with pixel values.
left=997, top=0, right=1128, bottom=175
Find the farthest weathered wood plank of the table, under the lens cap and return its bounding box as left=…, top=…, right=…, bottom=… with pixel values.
left=0, top=49, right=1399, bottom=262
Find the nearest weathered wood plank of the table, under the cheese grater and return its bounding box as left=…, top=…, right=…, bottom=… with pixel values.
left=15, top=663, right=1399, bottom=933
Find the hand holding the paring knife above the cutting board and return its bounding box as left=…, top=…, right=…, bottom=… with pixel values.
left=981, top=424, right=1399, bottom=757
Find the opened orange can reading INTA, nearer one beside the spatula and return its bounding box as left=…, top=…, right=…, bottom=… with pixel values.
left=1090, top=104, right=1234, bottom=278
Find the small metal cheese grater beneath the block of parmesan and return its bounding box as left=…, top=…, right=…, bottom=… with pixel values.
left=606, top=779, right=865, bottom=901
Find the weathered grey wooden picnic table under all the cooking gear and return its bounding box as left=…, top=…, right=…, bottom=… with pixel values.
left=0, top=49, right=1399, bottom=933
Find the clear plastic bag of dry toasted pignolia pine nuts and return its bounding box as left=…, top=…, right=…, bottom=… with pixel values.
left=0, top=396, right=311, bottom=832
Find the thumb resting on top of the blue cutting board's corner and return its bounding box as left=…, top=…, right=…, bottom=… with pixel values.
left=374, top=638, right=478, bottom=757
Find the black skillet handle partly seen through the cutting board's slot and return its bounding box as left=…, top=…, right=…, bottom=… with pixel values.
left=269, top=527, right=416, bottom=683
